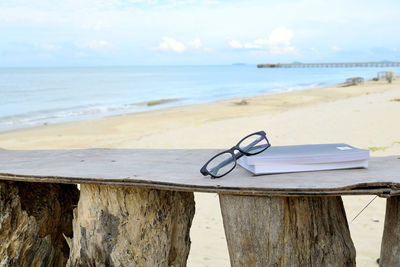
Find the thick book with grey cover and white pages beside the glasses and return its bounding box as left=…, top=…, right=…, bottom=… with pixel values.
left=238, top=144, right=369, bottom=174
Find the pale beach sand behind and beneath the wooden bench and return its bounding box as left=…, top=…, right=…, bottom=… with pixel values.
left=0, top=79, right=400, bottom=266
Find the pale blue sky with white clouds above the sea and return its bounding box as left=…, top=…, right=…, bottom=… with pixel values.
left=0, top=0, right=400, bottom=67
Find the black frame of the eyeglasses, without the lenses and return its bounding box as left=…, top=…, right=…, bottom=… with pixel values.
left=200, top=131, right=271, bottom=179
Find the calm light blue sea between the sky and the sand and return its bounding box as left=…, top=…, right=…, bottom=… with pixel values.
left=0, top=64, right=400, bottom=132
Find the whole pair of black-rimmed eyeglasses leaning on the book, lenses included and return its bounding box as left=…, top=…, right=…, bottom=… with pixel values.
left=200, top=131, right=271, bottom=178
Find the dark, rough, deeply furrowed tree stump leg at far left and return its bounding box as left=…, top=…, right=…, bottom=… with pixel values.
left=0, top=181, right=79, bottom=267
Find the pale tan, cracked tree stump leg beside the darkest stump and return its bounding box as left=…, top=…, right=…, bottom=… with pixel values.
left=67, top=184, right=195, bottom=266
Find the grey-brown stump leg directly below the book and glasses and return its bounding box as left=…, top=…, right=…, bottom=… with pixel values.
left=219, top=194, right=356, bottom=267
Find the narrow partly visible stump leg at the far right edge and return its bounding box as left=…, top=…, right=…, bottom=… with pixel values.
left=379, top=196, right=400, bottom=267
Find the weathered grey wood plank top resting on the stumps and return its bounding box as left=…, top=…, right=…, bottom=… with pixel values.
left=0, top=149, right=400, bottom=196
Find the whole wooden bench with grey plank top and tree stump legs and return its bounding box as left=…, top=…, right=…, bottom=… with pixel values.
left=0, top=149, right=400, bottom=266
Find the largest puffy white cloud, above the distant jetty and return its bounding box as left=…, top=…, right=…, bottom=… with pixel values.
left=229, top=27, right=297, bottom=54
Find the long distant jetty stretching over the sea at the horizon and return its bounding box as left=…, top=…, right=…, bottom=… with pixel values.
left=257, top=62, right=400, bottom=68
